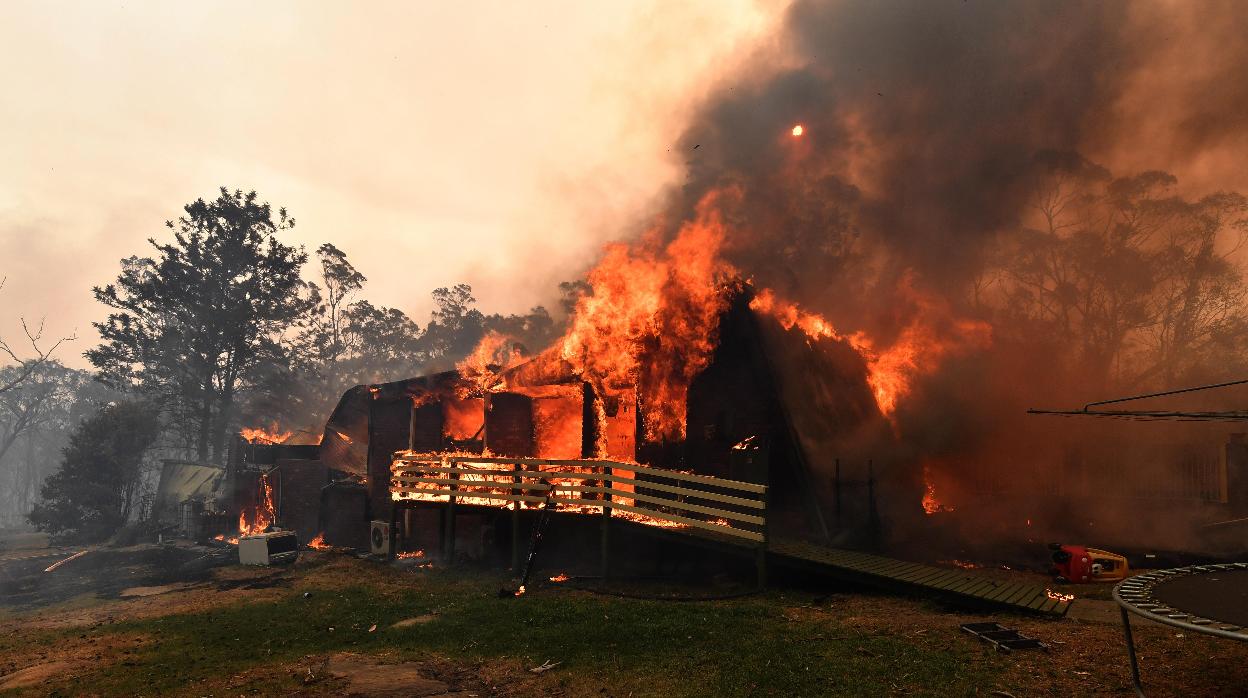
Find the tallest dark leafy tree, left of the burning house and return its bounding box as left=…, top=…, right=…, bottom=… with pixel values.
left=86, top=187, right=316, bottom=462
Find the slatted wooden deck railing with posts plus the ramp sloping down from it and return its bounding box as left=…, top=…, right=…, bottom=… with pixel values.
left=391, top=452, right=1070, bottom=616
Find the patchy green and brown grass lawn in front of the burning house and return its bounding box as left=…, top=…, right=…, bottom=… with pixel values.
left=0, top=553, right=1243, bottom=697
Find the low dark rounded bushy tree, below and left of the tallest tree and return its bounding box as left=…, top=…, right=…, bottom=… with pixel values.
left=29, top=402, right=160, bottom=542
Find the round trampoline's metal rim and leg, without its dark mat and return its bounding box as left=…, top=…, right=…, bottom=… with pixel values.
left=1113, top=562, right=1248, bottom=696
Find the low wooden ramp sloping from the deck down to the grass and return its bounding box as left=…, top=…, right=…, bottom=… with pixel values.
left=768, top=538, right=1071, bottom=616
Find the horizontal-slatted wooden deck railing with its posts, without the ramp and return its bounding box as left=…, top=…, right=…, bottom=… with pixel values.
left=391, top=451, right=768, bottom=581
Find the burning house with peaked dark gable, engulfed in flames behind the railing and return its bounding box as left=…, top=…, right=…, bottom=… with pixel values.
left=321, top=285, right=920, bottom=559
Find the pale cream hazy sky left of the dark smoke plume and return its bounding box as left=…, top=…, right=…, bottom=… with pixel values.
left=0, top=0, right=781, bottom=366
